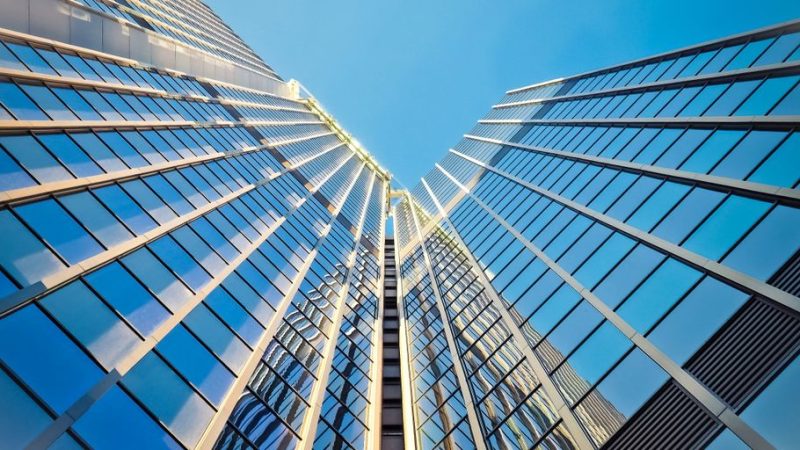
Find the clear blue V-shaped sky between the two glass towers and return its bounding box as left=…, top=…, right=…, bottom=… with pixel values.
left=207, top=0, right=800, bottom=187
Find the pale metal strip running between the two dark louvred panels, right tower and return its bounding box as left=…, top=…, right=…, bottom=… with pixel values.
left=437, top=164, right=774, bottom=450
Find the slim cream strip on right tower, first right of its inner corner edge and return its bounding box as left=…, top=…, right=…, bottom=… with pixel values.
left=406, top=193, right=486, bottom=450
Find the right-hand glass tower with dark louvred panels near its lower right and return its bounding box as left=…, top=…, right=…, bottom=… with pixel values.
left=393, top=22, right=800, bottom=450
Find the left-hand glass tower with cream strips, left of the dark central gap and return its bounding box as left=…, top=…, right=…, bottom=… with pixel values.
left=0, top=0, right=389, bottom=450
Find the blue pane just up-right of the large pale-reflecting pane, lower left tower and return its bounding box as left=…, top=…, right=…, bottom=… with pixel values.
left=86, top=262, right=170, bottom=336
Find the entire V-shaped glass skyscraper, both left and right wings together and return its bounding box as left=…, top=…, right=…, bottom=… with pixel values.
left=0, top=0, right=800, bottom=450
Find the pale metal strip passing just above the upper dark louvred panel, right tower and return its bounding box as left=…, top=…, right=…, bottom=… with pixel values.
left=451, top=150, right=800, bottom=312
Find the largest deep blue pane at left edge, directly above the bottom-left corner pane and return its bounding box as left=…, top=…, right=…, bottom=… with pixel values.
left=0, top=305, right=103, bottom=413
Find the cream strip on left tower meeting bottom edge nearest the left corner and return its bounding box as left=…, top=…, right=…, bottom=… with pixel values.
left=25, top=152, right=360, bottom=448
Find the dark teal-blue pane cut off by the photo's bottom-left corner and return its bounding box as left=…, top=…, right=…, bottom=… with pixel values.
left=0, top=369, right=51, bottom=449
